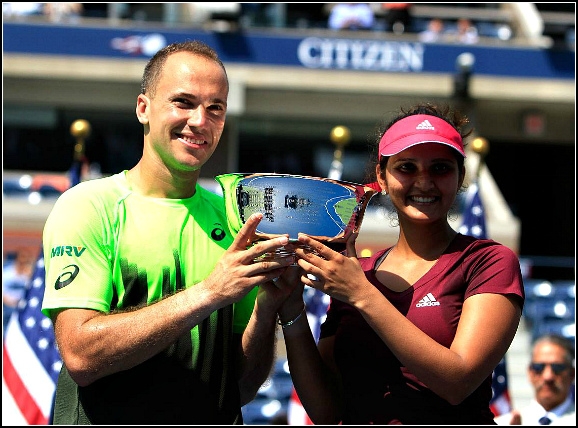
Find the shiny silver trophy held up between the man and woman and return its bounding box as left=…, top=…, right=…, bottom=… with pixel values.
left=215, top=173, right=376, bottom=260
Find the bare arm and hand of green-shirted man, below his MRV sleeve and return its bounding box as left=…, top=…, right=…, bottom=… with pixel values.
left=53, top=215, right=291, bottom=388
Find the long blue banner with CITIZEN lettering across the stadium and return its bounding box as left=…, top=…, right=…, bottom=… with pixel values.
left=3, top=22, right=575, bottom=79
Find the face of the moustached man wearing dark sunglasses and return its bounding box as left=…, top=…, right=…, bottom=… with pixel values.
left=528, top=343, right=574, bottom=410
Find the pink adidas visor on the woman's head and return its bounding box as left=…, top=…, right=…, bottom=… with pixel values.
left=379, top=114, right=466, bottom=157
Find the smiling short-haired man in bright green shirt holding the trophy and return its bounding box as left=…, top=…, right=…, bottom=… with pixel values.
left=42, top=41, right=293, bottom=425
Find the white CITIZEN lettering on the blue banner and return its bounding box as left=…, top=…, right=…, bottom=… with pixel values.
left=297, top=37, right=424, bottom=72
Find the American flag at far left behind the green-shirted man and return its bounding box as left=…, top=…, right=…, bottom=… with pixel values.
left=2, top=159, right=86, bottom=426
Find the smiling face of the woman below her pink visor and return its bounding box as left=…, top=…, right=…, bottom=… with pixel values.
left=379, top=143, right=464, bottom=223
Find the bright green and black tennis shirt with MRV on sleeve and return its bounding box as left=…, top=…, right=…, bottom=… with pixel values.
left=42, top=171, right=257, bottom=424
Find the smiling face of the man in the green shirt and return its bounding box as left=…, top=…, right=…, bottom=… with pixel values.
left=137, top=52, right=229, bottom=172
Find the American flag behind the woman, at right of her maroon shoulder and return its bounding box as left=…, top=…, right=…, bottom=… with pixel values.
left=459, top=183, right=512, bottom=416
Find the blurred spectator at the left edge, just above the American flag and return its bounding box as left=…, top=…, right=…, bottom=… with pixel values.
left=2, top=248, right=35, bottom=332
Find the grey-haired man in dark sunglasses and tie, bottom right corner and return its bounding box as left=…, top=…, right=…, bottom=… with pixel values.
left=494, top=335, right=576, bottom=426
